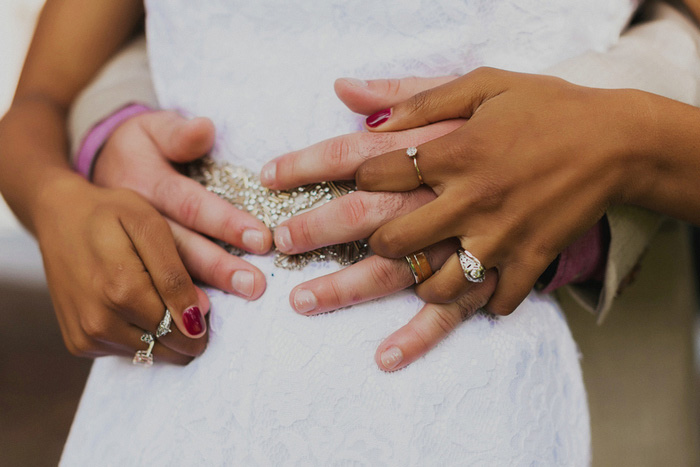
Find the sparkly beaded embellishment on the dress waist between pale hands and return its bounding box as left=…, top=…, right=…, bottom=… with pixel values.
left=185, top=157, right=369, bottom=269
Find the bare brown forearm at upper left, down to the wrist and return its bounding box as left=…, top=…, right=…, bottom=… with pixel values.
left=0, top=0, right=142, bottom=233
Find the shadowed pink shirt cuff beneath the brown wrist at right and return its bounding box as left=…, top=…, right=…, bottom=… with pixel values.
left=542, top=218, right=610, bottom=293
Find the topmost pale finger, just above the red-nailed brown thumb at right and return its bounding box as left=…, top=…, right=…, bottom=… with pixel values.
left=334, top=76, right=457, bottom=115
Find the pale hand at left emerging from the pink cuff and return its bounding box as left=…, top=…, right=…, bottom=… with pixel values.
left=93, top=111, right=272, bottom=300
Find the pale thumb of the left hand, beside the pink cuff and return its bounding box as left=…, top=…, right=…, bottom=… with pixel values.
left=143, top=110, right=215, bottom=163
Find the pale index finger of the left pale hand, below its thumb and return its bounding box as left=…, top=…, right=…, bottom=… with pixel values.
left=153, top=170, right=272, bottom=254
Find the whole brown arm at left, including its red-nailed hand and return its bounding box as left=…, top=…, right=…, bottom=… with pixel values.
left=0, top=0, right=208, bottom=363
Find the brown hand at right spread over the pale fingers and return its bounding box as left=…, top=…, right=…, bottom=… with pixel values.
left=356, top=68, right=633, bottom=314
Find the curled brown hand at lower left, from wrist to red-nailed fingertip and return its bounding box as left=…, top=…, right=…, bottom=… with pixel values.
left=35, top=175, right=209, bottom=364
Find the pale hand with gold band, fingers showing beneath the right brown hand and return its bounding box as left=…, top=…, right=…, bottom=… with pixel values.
left=261, top=77, right=496, bottom=371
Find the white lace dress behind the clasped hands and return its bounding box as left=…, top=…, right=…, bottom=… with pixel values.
left=62, top=0, right=635, bottom=466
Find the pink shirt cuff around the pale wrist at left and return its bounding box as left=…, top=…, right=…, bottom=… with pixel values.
left=73, top=104, right=151, bottom=180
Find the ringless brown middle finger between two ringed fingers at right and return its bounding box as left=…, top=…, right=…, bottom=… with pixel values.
left=369, top=197, right=462, bottom=258
